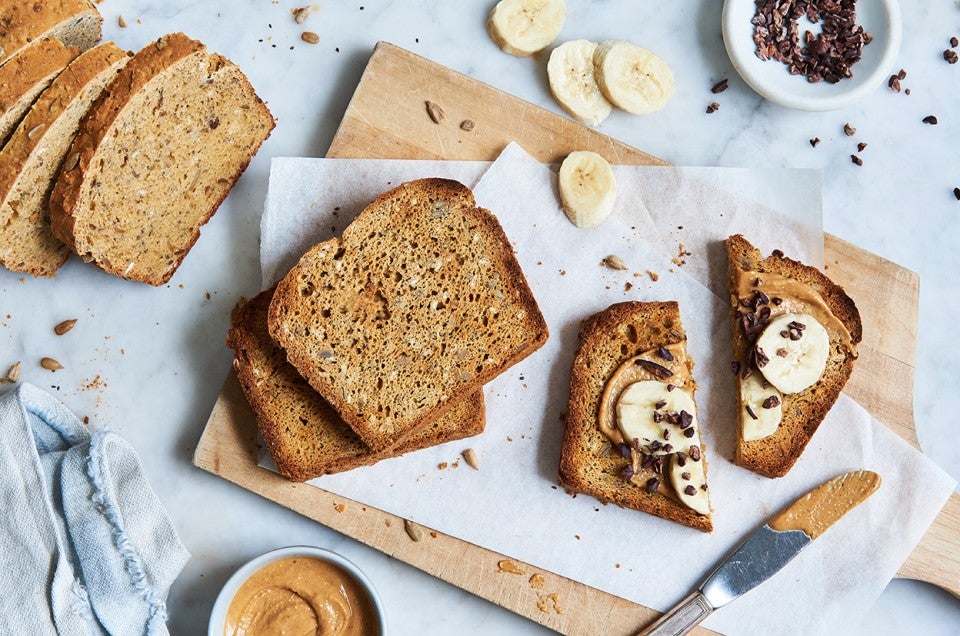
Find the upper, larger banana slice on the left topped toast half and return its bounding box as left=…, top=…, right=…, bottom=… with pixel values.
left=617, top=380, right=700, bottom=455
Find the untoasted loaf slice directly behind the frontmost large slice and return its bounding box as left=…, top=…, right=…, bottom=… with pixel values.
left=0, top=42, right=129, bottom=276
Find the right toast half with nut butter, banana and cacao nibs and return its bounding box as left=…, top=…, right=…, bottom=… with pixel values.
left=726, top=234, right=862, bottom=477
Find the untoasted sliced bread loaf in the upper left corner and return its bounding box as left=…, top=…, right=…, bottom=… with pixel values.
left=0, top=0, right=274, bottom=285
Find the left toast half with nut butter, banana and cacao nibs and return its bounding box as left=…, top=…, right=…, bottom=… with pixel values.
left=560, top=302, right=713, bottom=532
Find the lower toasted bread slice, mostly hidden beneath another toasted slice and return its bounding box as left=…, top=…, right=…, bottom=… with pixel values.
left=227, top=289, right=484, bottom=481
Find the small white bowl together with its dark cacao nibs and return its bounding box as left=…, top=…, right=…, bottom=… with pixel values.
left=722, top=0, right=901, bottom=110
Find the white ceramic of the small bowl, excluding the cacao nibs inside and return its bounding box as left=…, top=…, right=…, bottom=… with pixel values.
left=722, top=0, right=902, bottom=110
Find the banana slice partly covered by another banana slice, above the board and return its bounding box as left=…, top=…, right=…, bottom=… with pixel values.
left=547, top=40, right=613, bottom=126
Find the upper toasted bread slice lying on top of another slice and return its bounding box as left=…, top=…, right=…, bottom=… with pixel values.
left=270, top=179, right=547, bottom=450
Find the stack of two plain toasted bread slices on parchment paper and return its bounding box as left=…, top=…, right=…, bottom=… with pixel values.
left=227, top=179, right=547, bottom=480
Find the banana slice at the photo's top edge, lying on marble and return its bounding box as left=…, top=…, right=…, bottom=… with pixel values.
left=487, top=0, right=567, bottom=57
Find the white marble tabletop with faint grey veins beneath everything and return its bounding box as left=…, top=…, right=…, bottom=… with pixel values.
left=0, top=0, right=960, bottom=635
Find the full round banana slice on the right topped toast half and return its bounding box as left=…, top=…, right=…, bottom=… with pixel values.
left=757, top=314, right=830, bottom=394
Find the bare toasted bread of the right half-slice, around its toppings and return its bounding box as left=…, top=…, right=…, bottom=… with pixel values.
left=726, top=234, right=862, bottom=477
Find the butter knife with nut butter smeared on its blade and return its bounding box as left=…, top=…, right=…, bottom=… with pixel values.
left=638, top=470, right=880, bottom=636
